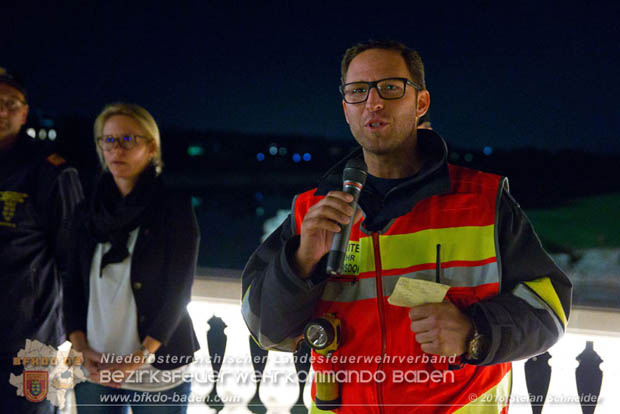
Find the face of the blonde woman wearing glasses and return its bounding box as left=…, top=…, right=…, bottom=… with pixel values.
left=101, top=115, right=155, bottom=180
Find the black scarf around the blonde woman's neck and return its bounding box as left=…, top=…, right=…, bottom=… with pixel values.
left=86, top=166, right=161, bottom=277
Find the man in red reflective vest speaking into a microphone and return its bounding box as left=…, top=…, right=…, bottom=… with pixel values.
left=242, top=41, right=571, bottom=413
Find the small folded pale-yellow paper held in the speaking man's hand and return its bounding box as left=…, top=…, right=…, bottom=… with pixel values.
left=388, top=277, right=450, bottom=308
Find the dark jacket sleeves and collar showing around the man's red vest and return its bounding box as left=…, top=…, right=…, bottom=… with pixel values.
left=242, top=130, right=572, bottom=365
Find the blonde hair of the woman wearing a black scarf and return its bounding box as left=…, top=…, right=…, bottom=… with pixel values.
left=94, top=102, right=164, bottom=175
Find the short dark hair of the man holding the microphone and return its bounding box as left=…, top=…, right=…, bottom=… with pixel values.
left=340, top=40, right=426, bottom=89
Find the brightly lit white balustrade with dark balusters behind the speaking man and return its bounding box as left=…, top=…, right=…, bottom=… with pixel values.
left=63, top=277, right=620, bottom=414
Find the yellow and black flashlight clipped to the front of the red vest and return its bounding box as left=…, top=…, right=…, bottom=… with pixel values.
left=304, top=313, right=341, bottom=410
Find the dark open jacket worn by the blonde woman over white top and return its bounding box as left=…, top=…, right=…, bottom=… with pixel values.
left=64, top=176, right=200, bottom=369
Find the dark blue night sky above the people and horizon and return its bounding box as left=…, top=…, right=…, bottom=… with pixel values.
left=0, top=1, right=620, bottom=153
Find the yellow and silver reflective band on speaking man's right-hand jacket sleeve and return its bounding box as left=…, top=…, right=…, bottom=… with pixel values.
left=512, top=277, right=567, bottom=333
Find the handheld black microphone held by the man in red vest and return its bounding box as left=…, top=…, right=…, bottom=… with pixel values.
left=327, top=158, right=368, bottom=276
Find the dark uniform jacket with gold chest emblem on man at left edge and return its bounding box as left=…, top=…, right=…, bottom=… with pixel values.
left=0, top=135, right=83, bottom=357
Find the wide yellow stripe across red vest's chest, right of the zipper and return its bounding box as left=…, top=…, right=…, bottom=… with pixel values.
left=379, top=225, right=495, bottom=270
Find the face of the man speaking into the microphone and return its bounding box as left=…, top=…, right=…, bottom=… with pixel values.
left=342, top=49, right=429, bottom=155
